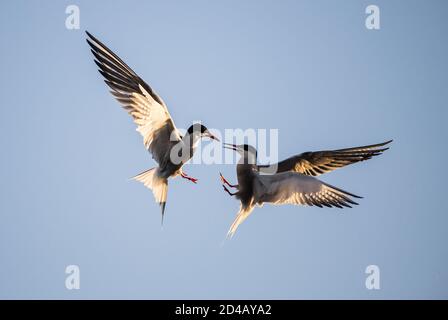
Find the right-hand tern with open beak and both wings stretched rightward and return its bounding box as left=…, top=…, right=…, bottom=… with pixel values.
left=220, top=140, right=392, bottom=237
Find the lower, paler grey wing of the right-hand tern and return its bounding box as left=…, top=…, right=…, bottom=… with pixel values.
left=254, top=172, right=361, bottom=208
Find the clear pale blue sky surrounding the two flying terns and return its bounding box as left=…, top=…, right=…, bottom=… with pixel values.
left=0, top=0, right=448, bottom=299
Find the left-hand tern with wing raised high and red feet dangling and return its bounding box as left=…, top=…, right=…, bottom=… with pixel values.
left=86, top=31, right=219, bottom=223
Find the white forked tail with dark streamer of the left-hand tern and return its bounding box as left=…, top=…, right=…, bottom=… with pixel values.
left=132, top=167, right=168, bottom=225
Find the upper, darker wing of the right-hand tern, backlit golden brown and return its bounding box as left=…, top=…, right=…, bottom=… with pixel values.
left=258, top=140, right=392, bottom=176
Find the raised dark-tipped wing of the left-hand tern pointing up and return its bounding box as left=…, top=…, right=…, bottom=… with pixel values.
left=86, top=31, right=180, bottom=163
